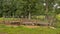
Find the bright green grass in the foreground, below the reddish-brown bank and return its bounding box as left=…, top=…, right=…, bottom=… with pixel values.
left=0, top=25, right=60, bottom=34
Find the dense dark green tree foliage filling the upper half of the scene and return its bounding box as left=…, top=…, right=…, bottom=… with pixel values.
left=0, top=0, right=59, bottom=17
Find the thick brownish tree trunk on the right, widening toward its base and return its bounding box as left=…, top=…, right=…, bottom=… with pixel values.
left=45, top=0, right=53, bottom=26
